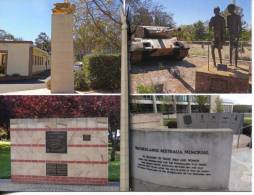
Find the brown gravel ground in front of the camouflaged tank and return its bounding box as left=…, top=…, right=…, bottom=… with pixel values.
left=131, top=56, right=251, bottom=94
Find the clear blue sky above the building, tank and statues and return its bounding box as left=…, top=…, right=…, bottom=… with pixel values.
left=0, top=0, right=251, bottom=41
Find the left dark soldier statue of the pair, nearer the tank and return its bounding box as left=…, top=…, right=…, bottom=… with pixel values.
left=209, top=7, right=226, bottom=67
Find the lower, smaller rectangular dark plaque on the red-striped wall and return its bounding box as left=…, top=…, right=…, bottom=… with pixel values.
left=46, top=163, right=68, bottom=176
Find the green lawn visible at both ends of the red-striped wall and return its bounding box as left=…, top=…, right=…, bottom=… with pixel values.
left=0, top=141, right=120, bottom=181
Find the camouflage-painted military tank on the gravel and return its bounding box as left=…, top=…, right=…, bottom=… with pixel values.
left=130, top=26, right=190, bottom=62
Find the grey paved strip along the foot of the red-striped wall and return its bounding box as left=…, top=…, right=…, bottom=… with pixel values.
left=0, top=179, right=120, bottom=192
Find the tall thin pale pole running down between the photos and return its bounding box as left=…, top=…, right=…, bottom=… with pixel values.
left=120, top=10, right=130, bottom=192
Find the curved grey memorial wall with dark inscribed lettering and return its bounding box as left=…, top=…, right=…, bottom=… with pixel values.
left=131, top=128, right=233, bottom=191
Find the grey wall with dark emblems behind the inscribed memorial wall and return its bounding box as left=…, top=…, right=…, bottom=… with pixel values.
left=177, top=113, right=244, bottom=134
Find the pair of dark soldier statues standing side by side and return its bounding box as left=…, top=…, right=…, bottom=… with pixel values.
left=209, top=4, right=241, bottom=67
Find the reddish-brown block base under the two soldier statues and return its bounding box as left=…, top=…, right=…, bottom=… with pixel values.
left=195, top=66, right=249, bottom=93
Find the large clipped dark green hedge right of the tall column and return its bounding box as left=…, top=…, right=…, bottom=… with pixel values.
left=84, top=54, right=121, bottom=90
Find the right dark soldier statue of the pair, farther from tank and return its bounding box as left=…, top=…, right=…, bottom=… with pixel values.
left=227, top=4, right=242, bottom=67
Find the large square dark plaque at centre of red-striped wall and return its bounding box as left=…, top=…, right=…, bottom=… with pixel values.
left=46, top=131, right=67, bottom=153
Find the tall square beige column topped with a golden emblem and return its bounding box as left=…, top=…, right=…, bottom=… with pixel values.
left=51, top=1, right=75, bottom=93
